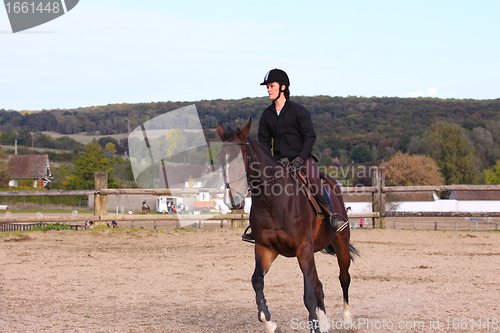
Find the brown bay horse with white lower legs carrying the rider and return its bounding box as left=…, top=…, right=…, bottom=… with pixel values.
left=217, top=118, right=357, bottom=333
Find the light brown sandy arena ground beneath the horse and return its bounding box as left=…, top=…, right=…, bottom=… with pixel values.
left=0, top=229, right=500, bottom=332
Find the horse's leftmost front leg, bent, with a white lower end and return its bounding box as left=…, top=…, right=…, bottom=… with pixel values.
left=252, top=244, right=281, bottom=333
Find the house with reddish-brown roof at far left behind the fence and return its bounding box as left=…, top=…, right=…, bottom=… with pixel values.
left=7, top=154, right=52, bottom=188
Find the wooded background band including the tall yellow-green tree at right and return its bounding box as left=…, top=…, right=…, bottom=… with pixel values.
left=0, top=96, right=500, bottom=184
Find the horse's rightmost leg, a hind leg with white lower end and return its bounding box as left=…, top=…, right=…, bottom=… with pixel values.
left=332, top=228, right=352, bottom=322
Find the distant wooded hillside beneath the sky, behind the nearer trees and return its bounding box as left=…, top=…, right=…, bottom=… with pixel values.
left=0, top=96, right=500, bottom=169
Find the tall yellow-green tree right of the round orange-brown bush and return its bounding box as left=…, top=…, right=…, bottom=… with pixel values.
left=431, top=124, right=477, bottom=185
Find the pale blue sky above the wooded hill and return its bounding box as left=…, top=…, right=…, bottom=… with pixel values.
left=0, top=0, right=500, bottom=111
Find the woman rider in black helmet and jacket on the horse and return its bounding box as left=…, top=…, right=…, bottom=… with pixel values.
left=243, top=69, right=348, bottom=241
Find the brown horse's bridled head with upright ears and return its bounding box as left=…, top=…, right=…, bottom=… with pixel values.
left=217, top=118, right=252, bottom=209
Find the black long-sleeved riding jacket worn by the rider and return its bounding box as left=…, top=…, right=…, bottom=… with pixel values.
left=258, top=100, right=316, bottom=161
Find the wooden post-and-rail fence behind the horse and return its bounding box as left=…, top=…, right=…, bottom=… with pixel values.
left=0, top=167, right=500, bottom=229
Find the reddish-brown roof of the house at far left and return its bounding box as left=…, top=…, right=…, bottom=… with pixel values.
left=7, top=154, right=49, bottom=179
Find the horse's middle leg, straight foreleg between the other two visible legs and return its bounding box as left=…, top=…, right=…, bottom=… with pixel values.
left=297, top=241, right=329, bottom=333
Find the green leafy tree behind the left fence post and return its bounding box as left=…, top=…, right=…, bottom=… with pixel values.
left=64, top=140, right=116, bottom=190
